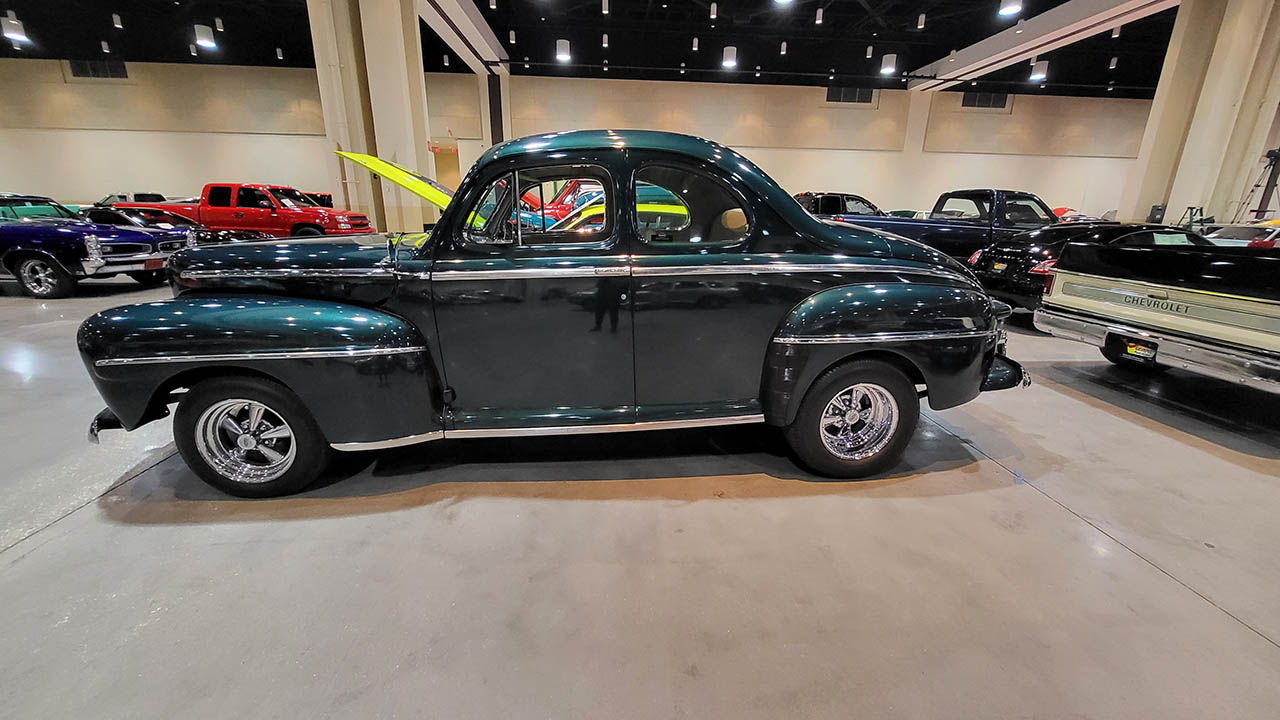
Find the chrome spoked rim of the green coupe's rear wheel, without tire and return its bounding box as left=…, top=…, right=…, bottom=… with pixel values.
left=818, top=383, right=899, bottom=460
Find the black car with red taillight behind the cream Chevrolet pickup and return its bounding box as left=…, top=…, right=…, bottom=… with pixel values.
left=969, top=223, right=1213, bottom=310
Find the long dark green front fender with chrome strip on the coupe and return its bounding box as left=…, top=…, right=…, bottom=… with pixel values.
left=77, top=295, right=443, bottom=443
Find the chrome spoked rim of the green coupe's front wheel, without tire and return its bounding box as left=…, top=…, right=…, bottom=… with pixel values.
left=195, top=398, right=297, bottom=484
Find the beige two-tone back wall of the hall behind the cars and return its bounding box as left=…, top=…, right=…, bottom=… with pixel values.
left=0, top=60, right=1149, bottom=213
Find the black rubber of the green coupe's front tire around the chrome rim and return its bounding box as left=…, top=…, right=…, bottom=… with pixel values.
left=173, top=377, right=329, bottom=497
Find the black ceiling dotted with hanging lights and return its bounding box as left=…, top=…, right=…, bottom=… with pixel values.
left=0, top=0, right=1176, bottom=97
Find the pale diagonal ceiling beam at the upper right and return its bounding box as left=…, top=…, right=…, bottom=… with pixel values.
left=908, top=0, right=1179, bottom=90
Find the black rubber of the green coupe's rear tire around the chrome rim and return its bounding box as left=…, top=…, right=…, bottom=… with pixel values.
left=786, top=360, right=920, bottom=478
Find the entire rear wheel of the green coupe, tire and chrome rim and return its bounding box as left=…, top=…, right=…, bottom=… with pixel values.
left=786, top=360, right=920, bottom=478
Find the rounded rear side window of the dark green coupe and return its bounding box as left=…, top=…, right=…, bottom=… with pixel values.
left=635, top=165, right=750, bottom=245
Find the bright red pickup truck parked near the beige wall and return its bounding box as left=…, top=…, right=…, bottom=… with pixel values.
left=116, top=183, right=378, bottom=237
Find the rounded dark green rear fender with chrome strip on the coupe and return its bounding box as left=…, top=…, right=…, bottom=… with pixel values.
left=760, top=283, right=998, bottom=425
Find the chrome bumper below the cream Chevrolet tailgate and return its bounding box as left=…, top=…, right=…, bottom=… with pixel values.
left=1036, top=302, right=1280, bottom=393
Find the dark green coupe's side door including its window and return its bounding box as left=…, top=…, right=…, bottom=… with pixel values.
left=430, top=159, right=635, bottom=434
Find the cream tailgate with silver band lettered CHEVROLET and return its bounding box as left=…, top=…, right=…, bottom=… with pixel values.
left=1044, top=270, right=1280, bottom=352
